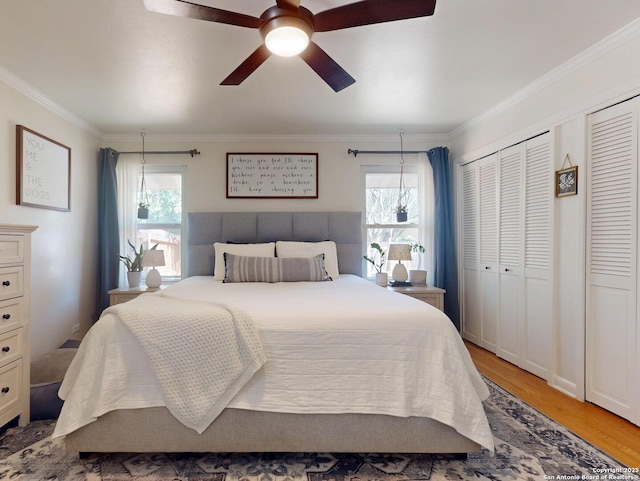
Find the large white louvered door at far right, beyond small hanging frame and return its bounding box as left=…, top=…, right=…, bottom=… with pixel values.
left=579, top=99, right=640, bottom=424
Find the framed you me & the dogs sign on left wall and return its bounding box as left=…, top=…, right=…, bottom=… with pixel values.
left=16, top=125, right=71, bottom=212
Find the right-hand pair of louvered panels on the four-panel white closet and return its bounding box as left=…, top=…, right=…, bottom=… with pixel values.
left=497, top=132, right=553, bottom=379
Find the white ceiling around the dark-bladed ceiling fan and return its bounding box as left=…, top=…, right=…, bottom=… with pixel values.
left=0, top=0, right=640, bottom=135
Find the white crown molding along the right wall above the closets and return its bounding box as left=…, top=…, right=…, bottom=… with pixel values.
left=449, top=18, right=640, bottom=142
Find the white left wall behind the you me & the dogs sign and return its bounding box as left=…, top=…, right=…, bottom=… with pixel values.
left=0, top=81, right=100, bottom=359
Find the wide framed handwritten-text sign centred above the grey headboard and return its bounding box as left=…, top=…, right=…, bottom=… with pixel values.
left=227, top=153, right=318, bottom=199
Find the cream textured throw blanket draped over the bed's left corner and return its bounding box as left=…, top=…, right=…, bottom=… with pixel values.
left=103, top=295, right=266, bottom=433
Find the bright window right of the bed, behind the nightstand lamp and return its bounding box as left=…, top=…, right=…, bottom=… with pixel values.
left=362, top=164, right=424, bottom=277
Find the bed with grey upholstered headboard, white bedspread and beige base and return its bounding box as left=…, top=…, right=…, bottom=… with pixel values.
left=54, top=212, right=493, bottom=453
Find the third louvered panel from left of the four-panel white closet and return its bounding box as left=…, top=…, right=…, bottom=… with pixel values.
left=496, top=144, right=523, bottom=365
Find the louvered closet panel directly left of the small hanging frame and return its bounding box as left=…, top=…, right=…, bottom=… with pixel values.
left=521, top=133, right=555, bottom=379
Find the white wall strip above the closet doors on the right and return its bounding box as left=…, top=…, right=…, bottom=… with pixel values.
left=451, top=27, right=640, bottom=159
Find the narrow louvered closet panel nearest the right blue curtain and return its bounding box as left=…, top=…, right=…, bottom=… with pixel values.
left=459, top=162, right=482, bottom=344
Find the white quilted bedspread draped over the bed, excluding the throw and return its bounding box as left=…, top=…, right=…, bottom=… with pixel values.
left=54, top=275, right=493, bottom=450
